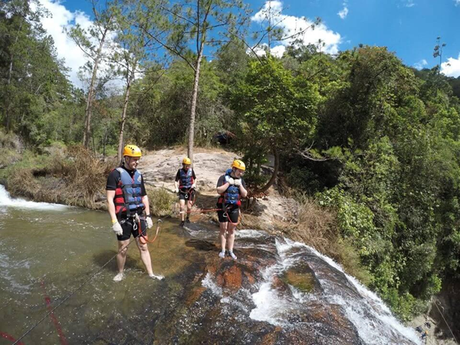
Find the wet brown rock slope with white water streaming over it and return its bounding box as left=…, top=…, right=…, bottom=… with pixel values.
left=146, top=224, right=416, bottom=345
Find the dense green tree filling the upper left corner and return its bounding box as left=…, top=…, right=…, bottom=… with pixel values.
left=0, top=0, right=70, bottom=147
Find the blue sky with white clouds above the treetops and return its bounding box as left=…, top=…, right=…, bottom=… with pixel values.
left=39, top=0, right=460, bottom=86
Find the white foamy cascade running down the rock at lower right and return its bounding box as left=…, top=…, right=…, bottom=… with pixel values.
left=250, top=239, right=420, bottom=345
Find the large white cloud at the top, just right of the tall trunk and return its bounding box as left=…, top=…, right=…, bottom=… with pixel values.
left=251, top=1, right=341, bottom=54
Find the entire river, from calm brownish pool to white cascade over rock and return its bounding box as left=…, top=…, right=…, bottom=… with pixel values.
left=0, top=186, right=419, bottom=345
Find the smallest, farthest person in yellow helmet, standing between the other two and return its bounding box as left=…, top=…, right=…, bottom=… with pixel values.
left=174, top=157, right=196, bottom=226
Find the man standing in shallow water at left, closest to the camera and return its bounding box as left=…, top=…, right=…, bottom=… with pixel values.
left=106, top=145, right=163, bottom=282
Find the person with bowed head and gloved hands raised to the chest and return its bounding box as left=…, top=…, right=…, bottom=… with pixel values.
left=217, top=159, right=248, bottom=260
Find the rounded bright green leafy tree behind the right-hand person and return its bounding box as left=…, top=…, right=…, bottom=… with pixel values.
left=233, top=56, right=319, bottom=191
